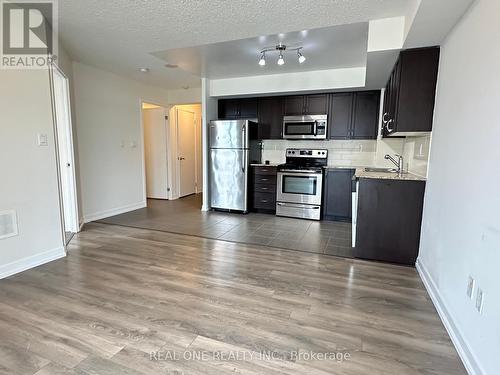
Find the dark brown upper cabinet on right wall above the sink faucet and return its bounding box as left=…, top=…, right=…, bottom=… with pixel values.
left=382, top=47, right=439, bottom=137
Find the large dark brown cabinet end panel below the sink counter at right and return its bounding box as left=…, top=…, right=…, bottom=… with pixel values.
left=354, top=178, right=425, bottom=266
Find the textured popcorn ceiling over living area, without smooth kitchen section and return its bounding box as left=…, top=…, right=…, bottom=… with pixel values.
left=59, top=0, right=472, bottom=88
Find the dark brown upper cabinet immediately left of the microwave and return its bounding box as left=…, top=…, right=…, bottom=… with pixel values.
left=258, top=96, right=283, bottom=139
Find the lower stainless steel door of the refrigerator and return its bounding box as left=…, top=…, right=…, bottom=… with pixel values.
left=210, top=149, right=248, bottom=212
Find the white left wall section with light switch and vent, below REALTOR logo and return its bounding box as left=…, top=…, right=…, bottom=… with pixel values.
left=0, top=70, right=65, bottom=278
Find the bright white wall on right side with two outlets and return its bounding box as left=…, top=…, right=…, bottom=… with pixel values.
left=419, top=0, right=500, bottom=375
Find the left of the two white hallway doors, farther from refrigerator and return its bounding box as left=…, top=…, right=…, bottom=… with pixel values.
left=142, top=108, right=168, bottom=199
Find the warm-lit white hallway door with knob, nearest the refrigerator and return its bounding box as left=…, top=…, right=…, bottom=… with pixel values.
left=177, top=109, right=197, bottom=197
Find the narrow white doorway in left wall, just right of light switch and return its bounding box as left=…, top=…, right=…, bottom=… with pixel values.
left=51, top=65, right=79, bottom=245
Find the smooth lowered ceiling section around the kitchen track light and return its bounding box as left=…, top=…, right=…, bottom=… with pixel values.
left=154, top=22, right=368, bottom=79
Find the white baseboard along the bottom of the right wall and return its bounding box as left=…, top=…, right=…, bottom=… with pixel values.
left=416, top=259, right=483, bottom=375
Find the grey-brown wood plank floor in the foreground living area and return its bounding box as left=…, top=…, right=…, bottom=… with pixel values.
left=0, top=224, right=466, bottom=375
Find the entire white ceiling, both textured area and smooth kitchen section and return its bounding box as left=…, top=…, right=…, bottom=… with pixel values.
left=59, top=0, right=472, bottom=89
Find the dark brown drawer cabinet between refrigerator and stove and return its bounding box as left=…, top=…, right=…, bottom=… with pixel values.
left=249, top=166, right=277, bottom=214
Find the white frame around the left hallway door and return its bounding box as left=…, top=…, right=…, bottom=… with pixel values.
left=139, top=98, right=172, bottom=201
